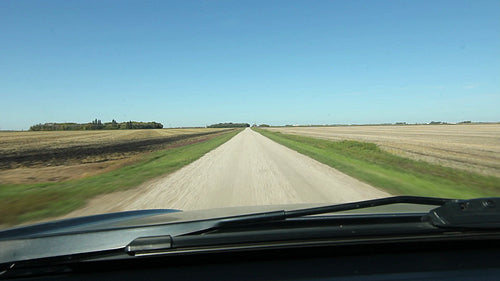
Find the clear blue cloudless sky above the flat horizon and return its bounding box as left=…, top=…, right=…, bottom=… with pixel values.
left=0, top=0, right=500, bottom=130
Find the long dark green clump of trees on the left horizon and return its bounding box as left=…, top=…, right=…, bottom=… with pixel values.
left=30, top=119, right=163, bottom=131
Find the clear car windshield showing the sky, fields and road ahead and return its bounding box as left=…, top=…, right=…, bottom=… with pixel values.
left=0, top=0, right=500, bottom=229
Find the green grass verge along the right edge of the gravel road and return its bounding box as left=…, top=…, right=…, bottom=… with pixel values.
left=255, top=129, right=500, bottom=199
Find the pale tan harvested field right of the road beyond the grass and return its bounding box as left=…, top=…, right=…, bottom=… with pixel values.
left=269, top=124, right=500, bottom=176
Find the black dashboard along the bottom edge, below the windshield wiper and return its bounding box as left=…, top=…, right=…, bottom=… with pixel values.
left=4, top=235, right=500, bottom=280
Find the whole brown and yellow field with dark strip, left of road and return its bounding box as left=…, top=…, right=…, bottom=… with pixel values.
left=0, top=128, right=227, bottom=184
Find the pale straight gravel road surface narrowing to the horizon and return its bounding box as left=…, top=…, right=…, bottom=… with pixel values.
left=65, top=128, right=390, bottom=217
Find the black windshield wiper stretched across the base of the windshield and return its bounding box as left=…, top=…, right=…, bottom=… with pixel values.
left=125, top=196, right=500, bottom=255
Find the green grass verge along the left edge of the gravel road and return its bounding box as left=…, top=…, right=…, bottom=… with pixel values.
left=0, top=129, right=241, bottom=225
